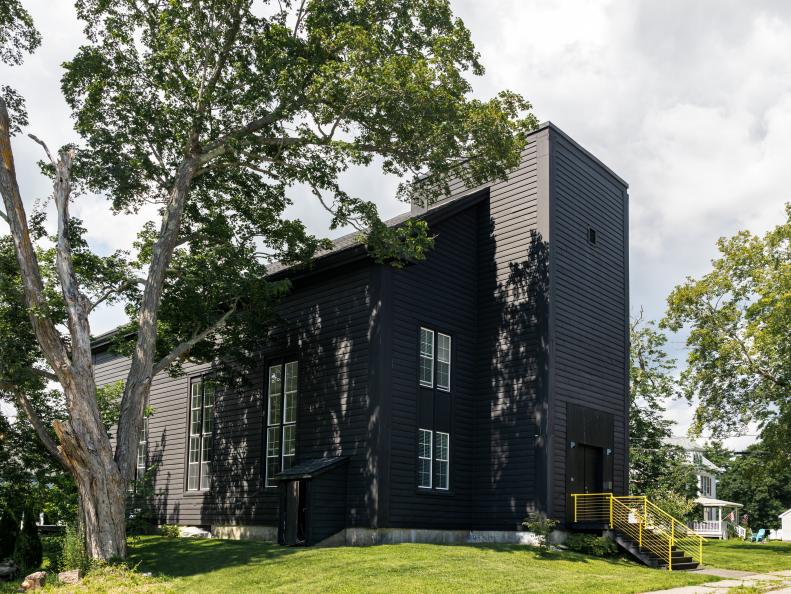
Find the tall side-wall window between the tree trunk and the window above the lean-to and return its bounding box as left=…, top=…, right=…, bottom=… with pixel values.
left=187, top=380, right=214, bottom=491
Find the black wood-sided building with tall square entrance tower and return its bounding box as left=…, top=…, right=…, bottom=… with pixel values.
left=95, top=124, right=629, bottom=544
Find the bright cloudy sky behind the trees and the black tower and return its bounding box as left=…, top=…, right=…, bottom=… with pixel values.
left=0, top=0, right=791, bottom=446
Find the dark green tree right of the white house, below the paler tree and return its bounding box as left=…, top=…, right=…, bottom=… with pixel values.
left=717, top=442, right=791, bottom=531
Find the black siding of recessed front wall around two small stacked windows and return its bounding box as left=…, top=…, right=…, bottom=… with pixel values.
left=388, top=207, right=477, bottom=529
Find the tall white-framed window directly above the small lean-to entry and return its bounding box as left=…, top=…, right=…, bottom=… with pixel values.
left=265, top=361, right=299, bottom=487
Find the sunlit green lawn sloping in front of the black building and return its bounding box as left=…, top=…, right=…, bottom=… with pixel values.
left=125, top=537, right=712, bottom=594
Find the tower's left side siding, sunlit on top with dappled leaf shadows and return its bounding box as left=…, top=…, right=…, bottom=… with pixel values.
left=472, top=135, right=547, bottom=530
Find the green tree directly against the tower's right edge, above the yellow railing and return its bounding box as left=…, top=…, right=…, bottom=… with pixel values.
left=629, top=312, right=697, bottom=498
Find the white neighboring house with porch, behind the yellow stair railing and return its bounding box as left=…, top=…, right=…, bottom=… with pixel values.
left=668, top=437, right=744, bottom=538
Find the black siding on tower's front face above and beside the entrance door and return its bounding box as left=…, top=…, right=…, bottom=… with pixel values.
left=550, top=131, right=629, bottom=518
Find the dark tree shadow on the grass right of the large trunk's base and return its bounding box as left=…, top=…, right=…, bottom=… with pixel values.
left=129, top=537, right=298, bottom=577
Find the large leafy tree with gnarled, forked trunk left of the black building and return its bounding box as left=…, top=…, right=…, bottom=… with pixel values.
left=0, top=0, right=536, bottom=558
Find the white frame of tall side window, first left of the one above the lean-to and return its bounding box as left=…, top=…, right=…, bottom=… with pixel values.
left=187, top=378, right=216, bottom=491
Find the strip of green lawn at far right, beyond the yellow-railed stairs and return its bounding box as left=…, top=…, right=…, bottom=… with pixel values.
left=703, top=539, right=791, bottom=573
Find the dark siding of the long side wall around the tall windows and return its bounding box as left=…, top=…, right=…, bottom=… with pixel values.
left=95, top=264, right=376, bottom=526
